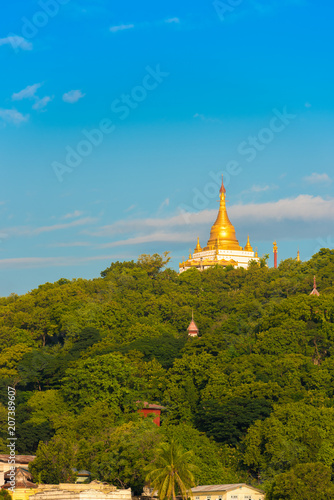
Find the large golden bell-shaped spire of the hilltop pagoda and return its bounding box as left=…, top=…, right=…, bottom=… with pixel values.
left=204, top=180, right=242, bottom=254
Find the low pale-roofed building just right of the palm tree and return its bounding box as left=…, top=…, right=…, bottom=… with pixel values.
left=191, top=483, right=265, bottom=500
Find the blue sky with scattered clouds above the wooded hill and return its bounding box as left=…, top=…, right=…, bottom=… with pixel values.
left=0, top=0, right=334, bottom=296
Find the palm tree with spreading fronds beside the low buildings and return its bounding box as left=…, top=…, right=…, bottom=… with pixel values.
left=145, top=440, right=198, bottom=500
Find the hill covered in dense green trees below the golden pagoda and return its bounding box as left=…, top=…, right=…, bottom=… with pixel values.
left=0, top=249, right=334, bottom=498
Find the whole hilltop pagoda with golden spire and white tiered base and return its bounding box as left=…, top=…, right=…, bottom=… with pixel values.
left=179, top=177, right=259, bottom=273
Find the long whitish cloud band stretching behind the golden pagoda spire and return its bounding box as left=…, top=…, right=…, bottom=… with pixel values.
left=83, top=195, right=334, bottom=248
